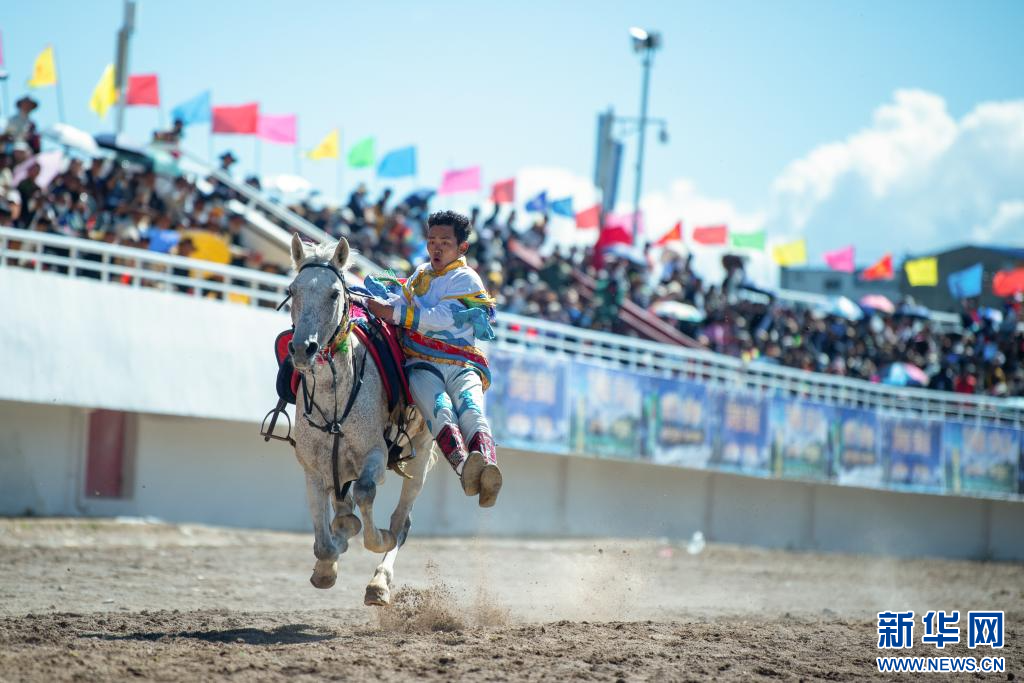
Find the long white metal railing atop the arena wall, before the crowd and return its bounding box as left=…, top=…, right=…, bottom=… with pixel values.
left=0, top=227, right=1024, bottom=427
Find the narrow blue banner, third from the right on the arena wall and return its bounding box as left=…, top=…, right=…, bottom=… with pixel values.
left=834, top=408, right=885, bottom=486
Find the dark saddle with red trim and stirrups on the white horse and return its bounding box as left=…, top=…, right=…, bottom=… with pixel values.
left=268, top=306, right=413, bottom=476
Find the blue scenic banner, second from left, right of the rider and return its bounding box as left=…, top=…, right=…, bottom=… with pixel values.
left=571, top=361, right=648, bottom=460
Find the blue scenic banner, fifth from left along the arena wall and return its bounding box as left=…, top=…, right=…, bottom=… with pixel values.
left=769, top=398, right=836, bottom=480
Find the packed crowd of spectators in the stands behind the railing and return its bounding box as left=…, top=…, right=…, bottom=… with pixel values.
left=6, top=92, right=1024, bottom=396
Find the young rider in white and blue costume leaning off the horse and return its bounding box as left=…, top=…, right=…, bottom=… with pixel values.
left=368, top=211, right=502, bottom=508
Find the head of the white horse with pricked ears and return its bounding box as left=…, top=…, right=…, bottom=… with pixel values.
left=288, top=234, right=351, bottom=371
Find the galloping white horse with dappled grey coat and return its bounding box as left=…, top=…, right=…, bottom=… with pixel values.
left=288, top=234, right=434, bottom=605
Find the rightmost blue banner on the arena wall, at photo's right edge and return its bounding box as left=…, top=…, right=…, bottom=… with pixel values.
left=942, top=422, right=1021, bottom=494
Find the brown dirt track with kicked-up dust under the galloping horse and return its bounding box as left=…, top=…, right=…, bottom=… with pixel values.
left=0, top=519, right=1024, bottom=681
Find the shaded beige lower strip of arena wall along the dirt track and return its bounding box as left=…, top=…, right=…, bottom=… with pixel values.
left=0, top=402, right=1024, bottom=560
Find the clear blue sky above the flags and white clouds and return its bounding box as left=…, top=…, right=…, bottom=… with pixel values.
left=0, top=0, right=1024, bottom=272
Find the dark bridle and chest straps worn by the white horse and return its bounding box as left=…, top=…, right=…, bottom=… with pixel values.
left=278, top=261, right=368, bottom=503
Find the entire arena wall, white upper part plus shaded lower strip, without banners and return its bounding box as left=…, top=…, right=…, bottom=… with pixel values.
left=0, top=268, right=1024, bottom=559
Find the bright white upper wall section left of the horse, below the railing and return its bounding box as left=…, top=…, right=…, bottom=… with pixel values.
left=0, top=267, right=280, bottom=421
